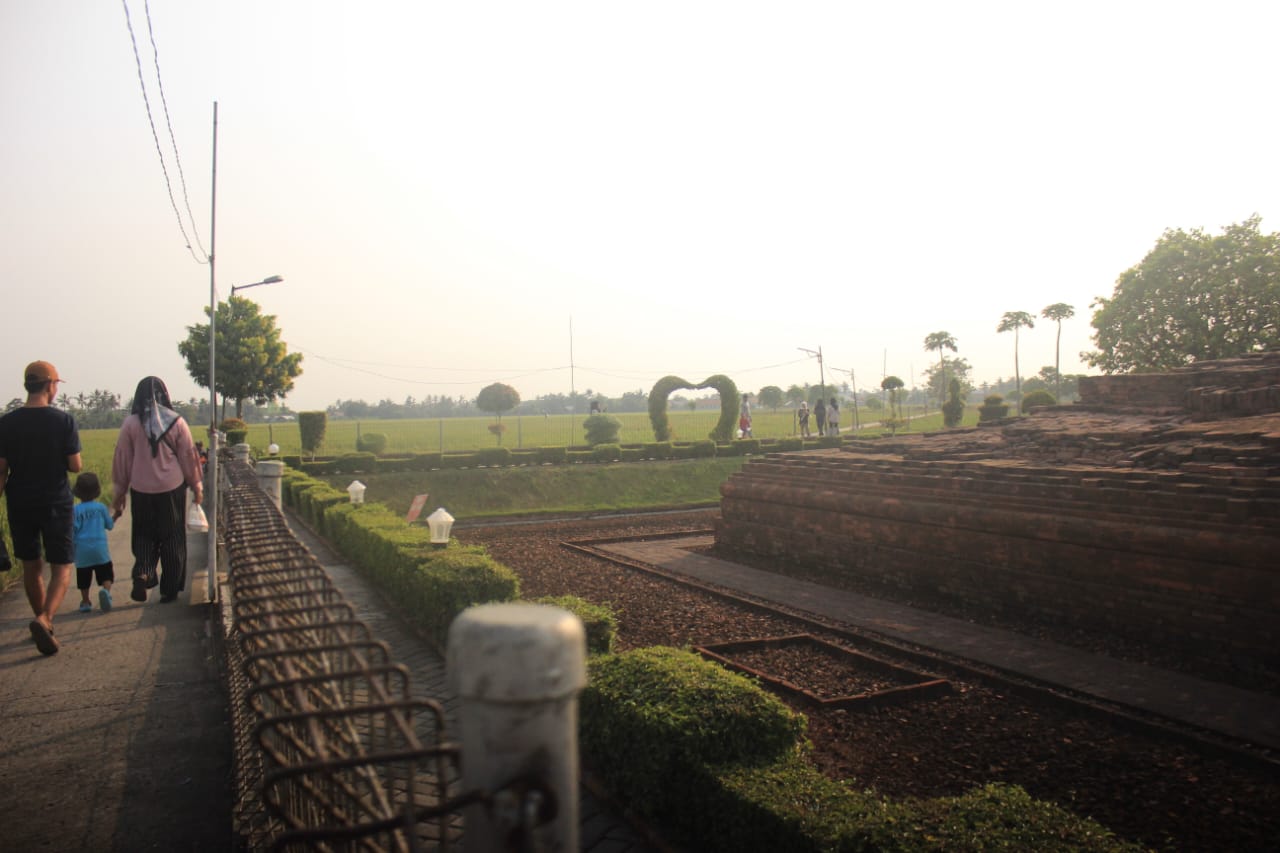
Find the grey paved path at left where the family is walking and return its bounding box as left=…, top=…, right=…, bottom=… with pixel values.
left=0, top=504, right=232, bottom=853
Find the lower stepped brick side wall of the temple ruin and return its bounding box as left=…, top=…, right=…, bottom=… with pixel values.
left=717, top=452, right=1280, bottom=669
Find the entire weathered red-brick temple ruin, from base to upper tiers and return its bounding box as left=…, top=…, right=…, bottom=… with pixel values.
left=716, top=352, right=1280, bottom=672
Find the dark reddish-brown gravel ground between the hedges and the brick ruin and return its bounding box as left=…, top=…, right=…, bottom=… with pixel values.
left=456, top=511, right=1280, bottom=852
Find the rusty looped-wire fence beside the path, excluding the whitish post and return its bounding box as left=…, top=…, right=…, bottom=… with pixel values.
left=220, top=462, right=465, bottom=850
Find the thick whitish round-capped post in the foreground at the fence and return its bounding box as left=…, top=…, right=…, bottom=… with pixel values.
left=447, top=603, right=586, bottom=853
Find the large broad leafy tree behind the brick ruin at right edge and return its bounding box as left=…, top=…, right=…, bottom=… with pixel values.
left=1080, top=215, right=1280, bottom=373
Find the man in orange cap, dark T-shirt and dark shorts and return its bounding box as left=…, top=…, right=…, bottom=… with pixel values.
left=0, top=361, right=82, bottom=654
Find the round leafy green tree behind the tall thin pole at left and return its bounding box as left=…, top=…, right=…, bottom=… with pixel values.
left=178, top=296, right=302, bottom=418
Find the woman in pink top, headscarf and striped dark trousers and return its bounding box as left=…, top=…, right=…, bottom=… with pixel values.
left=111, top=377, right=205, bottom=603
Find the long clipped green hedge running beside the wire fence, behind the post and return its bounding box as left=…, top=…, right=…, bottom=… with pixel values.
left=280, top=470, right=520, bottom=651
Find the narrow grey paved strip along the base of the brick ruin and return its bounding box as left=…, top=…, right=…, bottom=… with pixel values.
left=596, top=535, right=1280, bottom=749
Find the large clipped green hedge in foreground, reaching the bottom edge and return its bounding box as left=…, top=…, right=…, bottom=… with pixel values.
left=580, top=647, right=1142, bottom=853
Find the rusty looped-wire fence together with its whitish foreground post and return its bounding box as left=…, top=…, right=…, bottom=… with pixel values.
left=218, top=458, right=586, bottom=853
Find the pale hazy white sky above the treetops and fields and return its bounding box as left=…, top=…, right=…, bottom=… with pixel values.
left=0, top=0, right=1280, bottom=409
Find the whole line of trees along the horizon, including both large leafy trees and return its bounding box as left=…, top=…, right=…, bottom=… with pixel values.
left=5, top=214, right=1280, bottom=429
